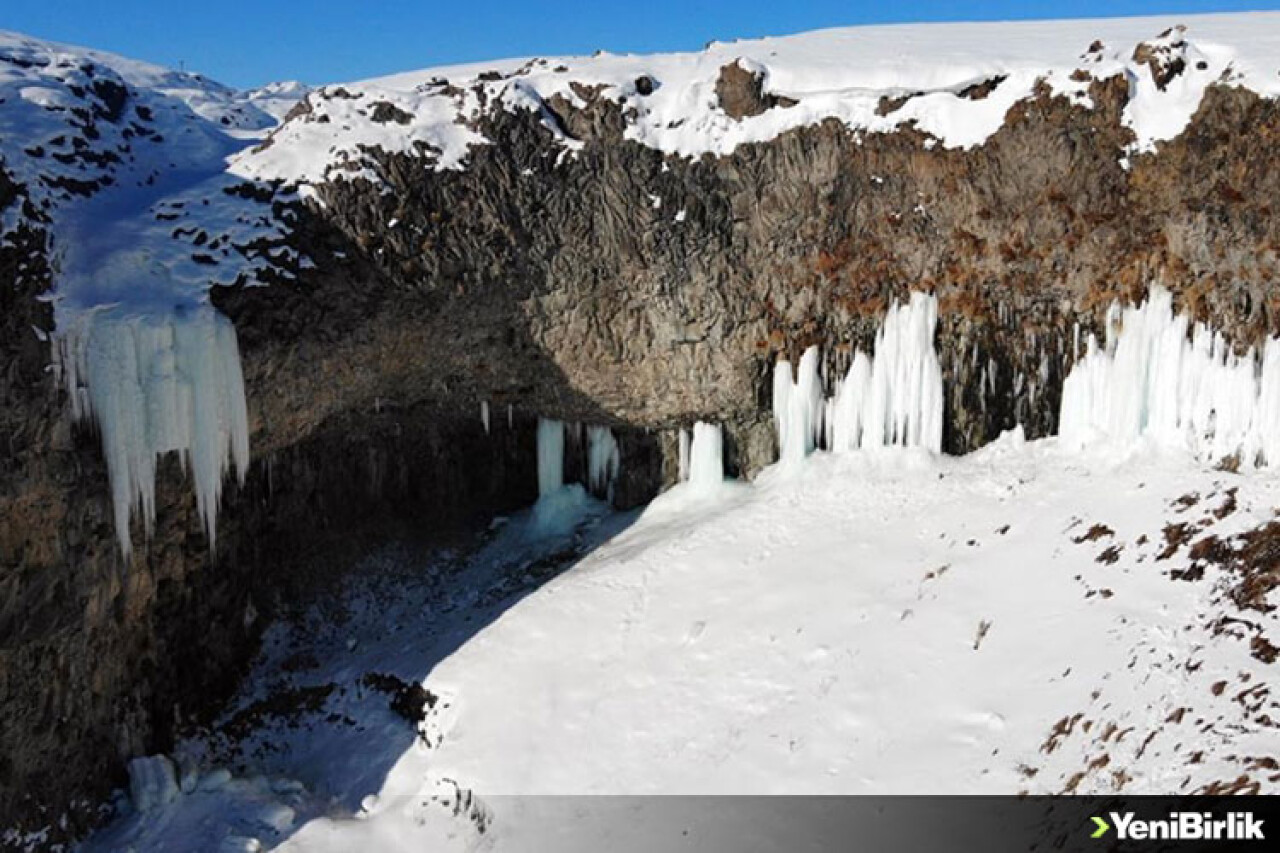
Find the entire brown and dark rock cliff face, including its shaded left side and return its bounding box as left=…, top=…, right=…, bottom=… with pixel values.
left=0, top=64, right=1280, bottom=845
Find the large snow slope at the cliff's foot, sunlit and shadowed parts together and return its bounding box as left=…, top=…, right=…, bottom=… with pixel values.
left=80, top=433, right=1280, bottom=850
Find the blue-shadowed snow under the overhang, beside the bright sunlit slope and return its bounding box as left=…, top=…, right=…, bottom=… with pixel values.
left=82, top=484, right=643, bottom=852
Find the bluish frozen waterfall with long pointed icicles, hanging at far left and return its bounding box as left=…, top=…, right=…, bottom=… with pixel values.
left=58, top=306, right=248, bottom=556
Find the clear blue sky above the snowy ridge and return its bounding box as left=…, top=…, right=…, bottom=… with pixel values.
left=0, top=0, right=1280, bottom=86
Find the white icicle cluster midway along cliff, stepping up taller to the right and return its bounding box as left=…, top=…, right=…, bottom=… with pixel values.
left=773, top=293, right=942, bottom=462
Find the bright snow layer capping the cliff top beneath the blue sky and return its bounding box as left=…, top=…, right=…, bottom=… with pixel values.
left=236, top=13, right=1280, bottom=189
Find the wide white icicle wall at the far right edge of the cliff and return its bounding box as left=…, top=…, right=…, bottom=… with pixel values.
left=1059, top=286, right=1280, bottom=465
